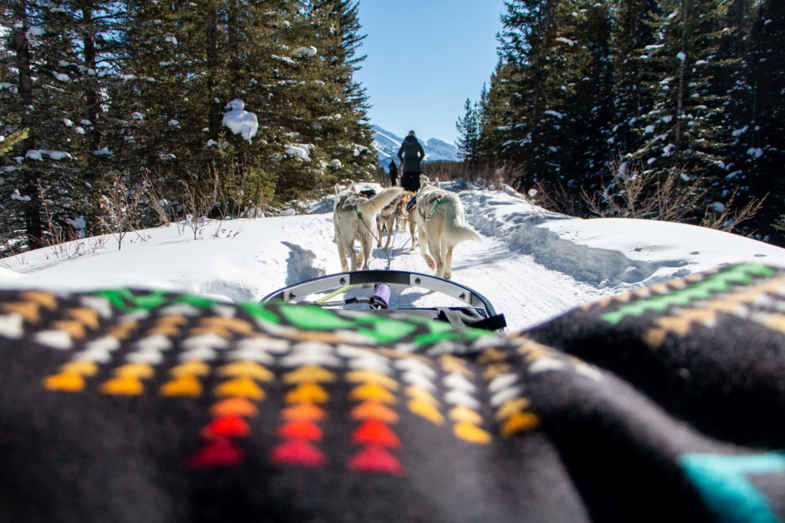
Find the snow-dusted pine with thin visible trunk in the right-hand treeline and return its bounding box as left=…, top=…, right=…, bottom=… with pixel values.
left=635, top=0, right=728, bottom=183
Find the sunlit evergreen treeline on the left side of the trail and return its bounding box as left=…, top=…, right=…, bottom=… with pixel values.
left=0, top=0, right=378, bottom=253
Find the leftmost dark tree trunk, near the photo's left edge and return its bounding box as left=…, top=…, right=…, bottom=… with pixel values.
left=13, top=0, right=43, bottom=249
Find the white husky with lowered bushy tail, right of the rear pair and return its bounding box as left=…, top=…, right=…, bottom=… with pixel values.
left=414, top=175, right=482, bottom=280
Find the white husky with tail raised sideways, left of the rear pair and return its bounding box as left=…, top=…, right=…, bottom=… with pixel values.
left=333, top=185, right=403, bottom=272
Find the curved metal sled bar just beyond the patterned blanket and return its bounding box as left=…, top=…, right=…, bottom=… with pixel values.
left=260, top=271, right=496, bottom=316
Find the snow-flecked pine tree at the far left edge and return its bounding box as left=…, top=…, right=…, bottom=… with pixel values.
left=0, top=0, right=85, bottom=248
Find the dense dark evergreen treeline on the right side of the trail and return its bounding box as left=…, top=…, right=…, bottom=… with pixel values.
left=457, top=0, right=785, bottom=245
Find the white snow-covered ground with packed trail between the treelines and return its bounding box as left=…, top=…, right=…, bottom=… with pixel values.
left=0, top=186, right=785, bottom=330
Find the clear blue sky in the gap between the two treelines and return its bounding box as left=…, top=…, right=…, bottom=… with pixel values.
left=355, top=0, right=504, bottom=142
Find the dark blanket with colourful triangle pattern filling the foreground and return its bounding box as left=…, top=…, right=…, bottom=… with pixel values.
left=0, top=265, right=785, bottom=523
